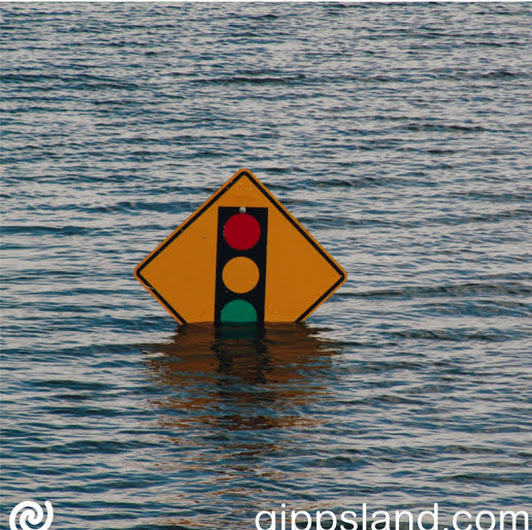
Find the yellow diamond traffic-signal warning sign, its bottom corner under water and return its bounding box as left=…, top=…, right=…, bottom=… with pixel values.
left=135, top=169, right=346, bottom=324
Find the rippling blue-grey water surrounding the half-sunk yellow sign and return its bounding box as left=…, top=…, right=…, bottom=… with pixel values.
left=0, top=3, right=532, bottom=530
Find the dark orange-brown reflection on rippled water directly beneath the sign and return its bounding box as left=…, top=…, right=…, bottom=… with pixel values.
left=146, top=324, right=334, bottom=430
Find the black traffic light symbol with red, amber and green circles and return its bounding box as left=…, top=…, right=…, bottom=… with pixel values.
left=214, top=206, right=268, bottom=324
